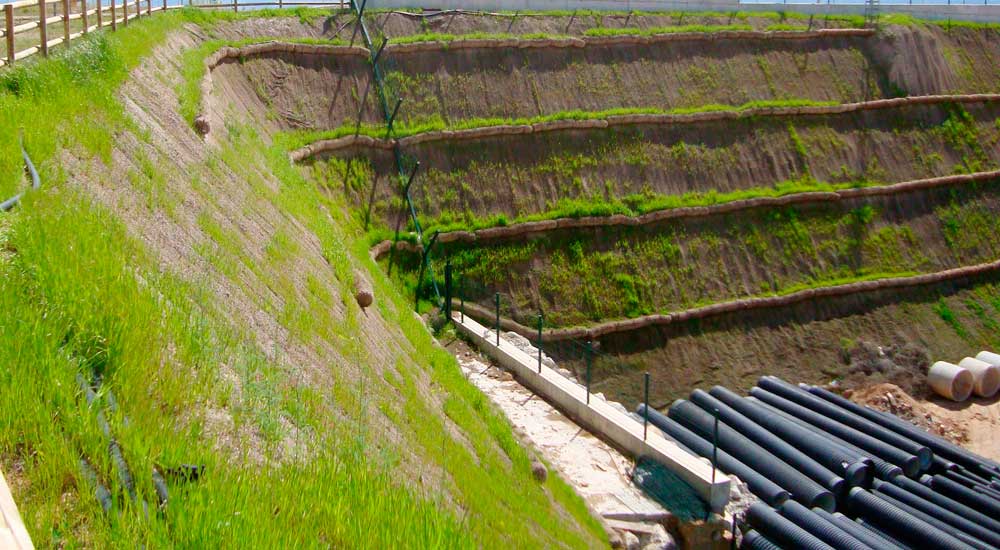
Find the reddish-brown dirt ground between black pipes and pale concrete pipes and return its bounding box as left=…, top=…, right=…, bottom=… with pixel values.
left=845, top=384, right=1000, bottom=460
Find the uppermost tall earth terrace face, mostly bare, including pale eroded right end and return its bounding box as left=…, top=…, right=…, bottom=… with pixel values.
left=203, top=24, right=1000, bottom=136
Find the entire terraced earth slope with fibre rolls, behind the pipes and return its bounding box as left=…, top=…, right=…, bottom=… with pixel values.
left=196, top=9, right=1000, bottom=405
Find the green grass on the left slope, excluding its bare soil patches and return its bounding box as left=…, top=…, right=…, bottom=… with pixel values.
left=0, top=13, right=600, bottom=547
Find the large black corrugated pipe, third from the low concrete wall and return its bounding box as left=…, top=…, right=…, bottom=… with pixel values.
left=691, top=390, right=867, bottom=496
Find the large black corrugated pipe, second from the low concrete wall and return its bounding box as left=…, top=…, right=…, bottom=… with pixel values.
left=667, top=399, right=843, bottom=512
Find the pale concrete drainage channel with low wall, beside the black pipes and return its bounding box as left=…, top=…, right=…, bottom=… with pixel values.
left=453, top=313, right=739, bottom=549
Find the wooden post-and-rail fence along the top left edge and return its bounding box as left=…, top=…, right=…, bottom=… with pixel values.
left=0, top=0, right=348, bottom=67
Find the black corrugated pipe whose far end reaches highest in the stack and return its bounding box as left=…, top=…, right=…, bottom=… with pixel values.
left=757, top=376, right=934, bottom=472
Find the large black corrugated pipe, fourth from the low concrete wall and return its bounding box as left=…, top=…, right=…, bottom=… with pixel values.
left=709, top=386, right=861, bottom=479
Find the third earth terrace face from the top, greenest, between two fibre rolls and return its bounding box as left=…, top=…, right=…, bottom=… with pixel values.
left=426, top=179, right=1000, bottom=326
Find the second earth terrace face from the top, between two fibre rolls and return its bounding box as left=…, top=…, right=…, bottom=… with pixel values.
left=302, top=96, right=1000, bottom=227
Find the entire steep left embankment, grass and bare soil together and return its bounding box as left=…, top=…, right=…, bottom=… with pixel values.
left=0, top=13, right=602, bottom=548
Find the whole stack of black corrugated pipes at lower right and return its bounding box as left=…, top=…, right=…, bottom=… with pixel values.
left=637, top=376, right=1000, bottom=550
